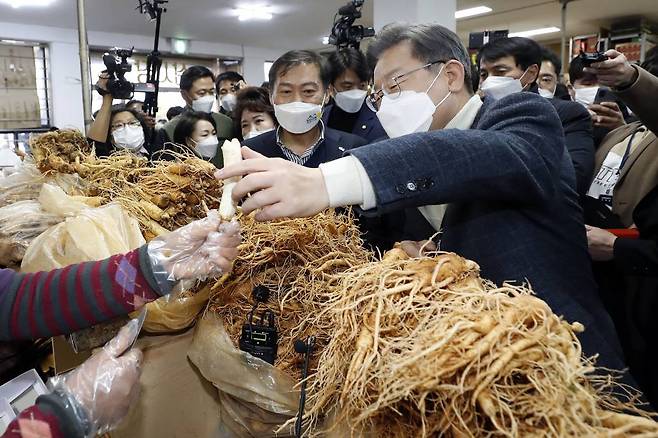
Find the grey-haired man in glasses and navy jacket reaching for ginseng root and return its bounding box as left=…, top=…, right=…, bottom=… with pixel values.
left=217, top=24, right=624, bottom=369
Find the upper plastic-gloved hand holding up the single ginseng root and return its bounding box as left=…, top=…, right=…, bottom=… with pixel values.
left=148, top=210, right=240, bottom=282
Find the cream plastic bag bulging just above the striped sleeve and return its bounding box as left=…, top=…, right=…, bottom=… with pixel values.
left=21, top=200, right=146, bottom=272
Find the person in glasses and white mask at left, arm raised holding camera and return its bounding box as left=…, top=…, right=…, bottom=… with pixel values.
left=88, top=72, right=151, bottom=157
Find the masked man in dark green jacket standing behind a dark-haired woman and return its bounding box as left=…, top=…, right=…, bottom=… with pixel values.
left=154, top=65, right=233, bottom=167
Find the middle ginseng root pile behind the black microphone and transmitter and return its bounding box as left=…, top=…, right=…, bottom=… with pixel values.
left=209, top=210, right=373, bottom=379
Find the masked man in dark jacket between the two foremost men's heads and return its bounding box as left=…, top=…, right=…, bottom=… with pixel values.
left=322, top=48, right=386, bottom=143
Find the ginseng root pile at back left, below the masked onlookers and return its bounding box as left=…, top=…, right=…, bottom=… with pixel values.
left=30, top=130, right=222, bottom=240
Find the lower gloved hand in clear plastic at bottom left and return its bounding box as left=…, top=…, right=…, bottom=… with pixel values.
left=50, top=319, right=142, bottom=437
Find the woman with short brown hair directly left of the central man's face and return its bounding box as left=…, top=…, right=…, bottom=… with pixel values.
left=233, top=87, right=278, bottom=140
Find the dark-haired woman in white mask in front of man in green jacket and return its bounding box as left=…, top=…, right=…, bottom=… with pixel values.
left=174, top=111, right=221, bottom=167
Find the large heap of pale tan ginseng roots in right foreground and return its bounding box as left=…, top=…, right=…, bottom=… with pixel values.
left=294, top=249, right=658, bottom=438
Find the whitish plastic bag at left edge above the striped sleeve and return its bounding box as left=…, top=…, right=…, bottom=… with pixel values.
left=0, top=201, right=64, bottom=267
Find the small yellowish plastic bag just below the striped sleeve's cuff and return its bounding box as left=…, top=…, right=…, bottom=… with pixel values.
left=144, top=285, right=210, bottom=333
